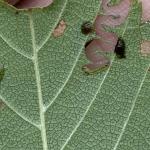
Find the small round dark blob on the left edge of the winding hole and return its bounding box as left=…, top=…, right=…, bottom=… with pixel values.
left=81, top=21, right=93, bottom=35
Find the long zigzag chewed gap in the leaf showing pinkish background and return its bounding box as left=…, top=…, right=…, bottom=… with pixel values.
left=83, top=0, right=131, bottom=73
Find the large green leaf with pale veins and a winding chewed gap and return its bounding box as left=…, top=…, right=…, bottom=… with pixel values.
left=0, top=0, right=150, bottom=150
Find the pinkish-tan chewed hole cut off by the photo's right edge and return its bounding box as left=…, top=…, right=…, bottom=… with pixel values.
left=141, top=40, right=150, bottom=56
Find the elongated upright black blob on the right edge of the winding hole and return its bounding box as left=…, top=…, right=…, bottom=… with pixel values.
left=114, top=37, right=126, bottom=59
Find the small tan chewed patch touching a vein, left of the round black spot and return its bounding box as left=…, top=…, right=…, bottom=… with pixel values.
left=53, top=20, right=67, bottom=37
